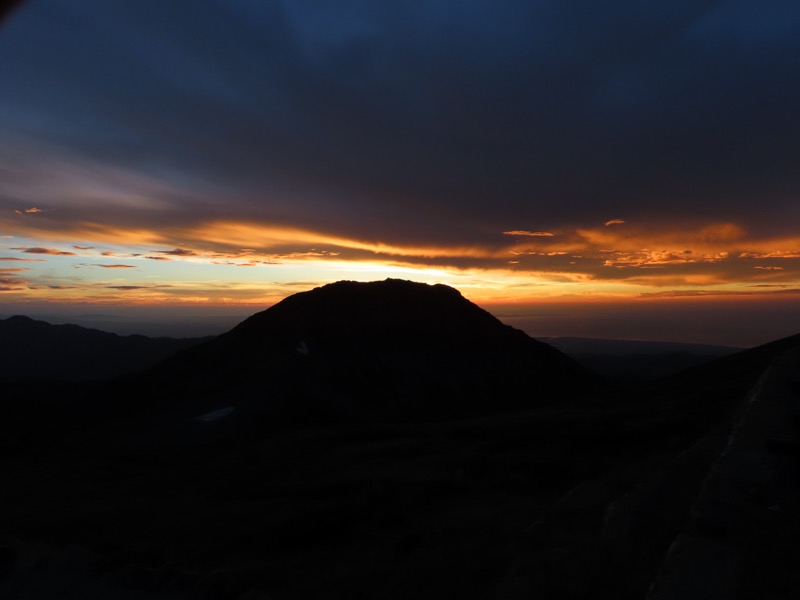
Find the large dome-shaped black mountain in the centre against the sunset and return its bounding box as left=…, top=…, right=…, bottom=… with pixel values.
left=139, top=279, right=603, bottom=420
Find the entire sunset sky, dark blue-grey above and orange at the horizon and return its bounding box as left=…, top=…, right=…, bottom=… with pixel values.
left=0, top=0, right=800, bottom=346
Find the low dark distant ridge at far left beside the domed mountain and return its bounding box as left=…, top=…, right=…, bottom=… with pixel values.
left=0, top=316, right=202, bottom=382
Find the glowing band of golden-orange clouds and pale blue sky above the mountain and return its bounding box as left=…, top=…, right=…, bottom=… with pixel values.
left=0, top=215, right=800, bottom=304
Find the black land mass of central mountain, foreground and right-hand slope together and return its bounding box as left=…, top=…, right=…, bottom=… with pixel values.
left=0, top=280, right=800, bottom=600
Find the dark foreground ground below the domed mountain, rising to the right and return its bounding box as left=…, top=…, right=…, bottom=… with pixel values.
left=0, top=340, right=800, bottom=600
